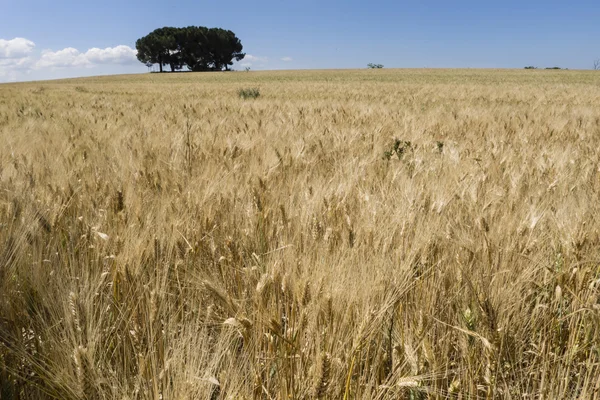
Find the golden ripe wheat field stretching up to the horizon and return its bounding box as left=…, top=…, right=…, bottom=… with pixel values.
left=0, top=70, right=600, bottom=400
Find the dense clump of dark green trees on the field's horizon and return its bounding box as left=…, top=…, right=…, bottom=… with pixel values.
left=135, top=26, right=245, bottom=72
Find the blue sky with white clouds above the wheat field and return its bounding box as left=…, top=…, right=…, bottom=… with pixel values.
left=0, top=0, right=600, bottom=82
